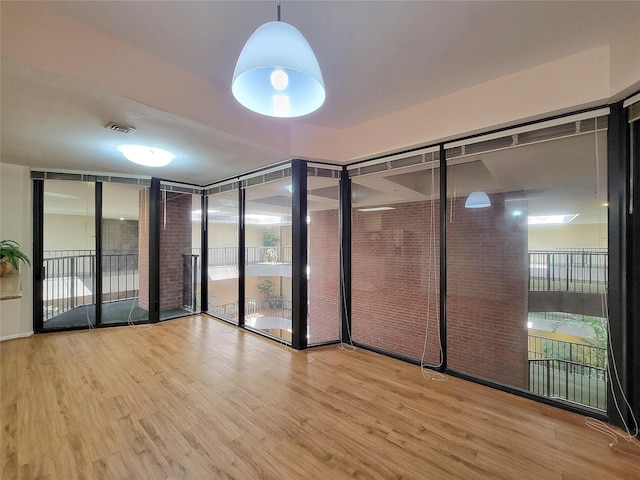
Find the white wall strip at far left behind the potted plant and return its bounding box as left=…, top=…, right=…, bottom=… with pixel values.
left=0, top=163, right=33, bottom=340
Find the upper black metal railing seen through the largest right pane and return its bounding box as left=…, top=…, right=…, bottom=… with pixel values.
left=529, top=249, right=609, bottom=293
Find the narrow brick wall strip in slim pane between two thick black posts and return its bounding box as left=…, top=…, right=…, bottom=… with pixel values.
left=308, top=210, right=340, bottom=344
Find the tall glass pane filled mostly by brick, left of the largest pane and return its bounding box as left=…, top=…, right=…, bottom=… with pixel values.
left=351, top=160, right=440, bottom=365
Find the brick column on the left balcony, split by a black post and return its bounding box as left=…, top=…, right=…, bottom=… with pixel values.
left=139, top=192, right=192, bottom=311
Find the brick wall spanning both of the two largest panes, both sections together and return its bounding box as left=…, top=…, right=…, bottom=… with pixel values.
left=352, top=194, right=527, bottom=388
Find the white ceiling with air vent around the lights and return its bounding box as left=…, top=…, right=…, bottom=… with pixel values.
left=0, top=0, right=640, bottom=185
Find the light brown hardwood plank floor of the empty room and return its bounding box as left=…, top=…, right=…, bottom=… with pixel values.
left=0, top=316, right=640, bottom=480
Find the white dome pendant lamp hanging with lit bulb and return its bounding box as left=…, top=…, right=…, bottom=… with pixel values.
left=231, top=3, right=325, bottom=118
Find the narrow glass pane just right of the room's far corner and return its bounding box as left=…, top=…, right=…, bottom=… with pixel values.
left=207, top=190, right=239, bottom=325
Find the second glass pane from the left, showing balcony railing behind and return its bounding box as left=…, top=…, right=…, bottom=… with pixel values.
left=101, top=183, right=149, bottom=324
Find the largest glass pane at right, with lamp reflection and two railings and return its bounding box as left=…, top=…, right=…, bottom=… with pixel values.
left=447, top=120, right=608, bottom=409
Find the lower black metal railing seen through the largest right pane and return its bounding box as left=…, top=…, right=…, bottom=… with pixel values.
left=529, top=358, right=607, bottom=410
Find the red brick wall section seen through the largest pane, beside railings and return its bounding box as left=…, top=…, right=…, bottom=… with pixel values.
left=447, top=194, right=528, bottom=388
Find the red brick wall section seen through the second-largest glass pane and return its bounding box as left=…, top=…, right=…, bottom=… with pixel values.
left=351, top=202, right=440, bottom=363
